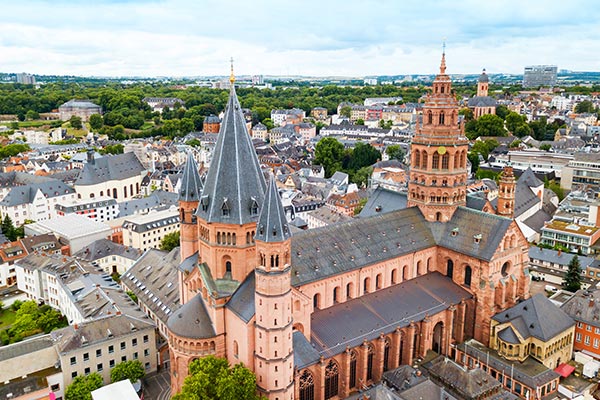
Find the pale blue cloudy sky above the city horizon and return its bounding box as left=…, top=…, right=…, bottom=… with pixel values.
left=0, top=0, right=600, bottom=77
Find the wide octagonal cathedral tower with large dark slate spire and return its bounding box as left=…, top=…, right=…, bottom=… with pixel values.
left=196, top=61, right=266, bottom=282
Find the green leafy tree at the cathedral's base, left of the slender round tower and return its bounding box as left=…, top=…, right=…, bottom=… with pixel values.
left=172, top=356, right=260, bottom=400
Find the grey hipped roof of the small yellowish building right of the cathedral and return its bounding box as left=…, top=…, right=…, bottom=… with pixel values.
left=492, top=293, right=575, bottom=342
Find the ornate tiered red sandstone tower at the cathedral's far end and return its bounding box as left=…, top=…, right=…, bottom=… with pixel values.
left=408, top=52, right=468, bottom=222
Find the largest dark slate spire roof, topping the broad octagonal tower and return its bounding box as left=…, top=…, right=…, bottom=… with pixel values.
left=196, top=83, right=266, bottom=225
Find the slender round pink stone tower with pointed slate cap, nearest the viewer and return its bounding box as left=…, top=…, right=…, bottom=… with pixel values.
left=254, top=177, right=294, bottom=400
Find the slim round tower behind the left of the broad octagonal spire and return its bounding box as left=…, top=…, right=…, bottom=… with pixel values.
left=179, top=152, right=202, bottom=261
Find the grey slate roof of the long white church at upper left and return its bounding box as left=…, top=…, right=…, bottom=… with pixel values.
left=75, top=153, right=146, bottom=186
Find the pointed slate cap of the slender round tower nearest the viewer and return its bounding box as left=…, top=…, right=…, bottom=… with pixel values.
left=255, top=176, right=292, bottom=243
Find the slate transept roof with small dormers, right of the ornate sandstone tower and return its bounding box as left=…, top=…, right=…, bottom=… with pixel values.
left=429, top=207, right=512, bottom=261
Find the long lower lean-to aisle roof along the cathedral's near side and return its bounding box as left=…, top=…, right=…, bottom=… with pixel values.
left=311, top=272, right=471, bottom=358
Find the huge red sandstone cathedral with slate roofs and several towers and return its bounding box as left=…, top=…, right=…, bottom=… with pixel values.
left=168, top=55, right=530, bottom=400
